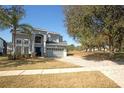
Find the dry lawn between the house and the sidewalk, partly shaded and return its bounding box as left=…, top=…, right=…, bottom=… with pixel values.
left=0, top=57, right=79, bottom=71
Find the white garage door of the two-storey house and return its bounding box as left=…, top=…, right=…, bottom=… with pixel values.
left=47, top=48, right=64, bottom=57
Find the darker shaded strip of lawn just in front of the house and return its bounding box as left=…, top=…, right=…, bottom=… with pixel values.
left=0, top=58, right=54, bottom=67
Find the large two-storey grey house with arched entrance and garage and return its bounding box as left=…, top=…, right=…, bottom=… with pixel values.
left=12, top=29, right=67, bottom=57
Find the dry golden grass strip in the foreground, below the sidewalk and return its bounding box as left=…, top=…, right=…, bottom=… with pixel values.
left=0, top=71, right=119, bottom=88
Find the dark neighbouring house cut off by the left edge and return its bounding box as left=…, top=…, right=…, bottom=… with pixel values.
left=0, top=38, right=7, bottom=55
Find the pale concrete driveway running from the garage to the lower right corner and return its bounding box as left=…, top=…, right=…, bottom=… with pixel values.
left=57, top=56, right=124, bottom=88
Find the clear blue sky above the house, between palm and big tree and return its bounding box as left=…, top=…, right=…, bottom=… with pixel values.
left=0, top=5, right=77, bottom=45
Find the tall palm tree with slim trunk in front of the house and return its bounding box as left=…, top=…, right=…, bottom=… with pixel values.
left=0, top=6, right=33, bottom=57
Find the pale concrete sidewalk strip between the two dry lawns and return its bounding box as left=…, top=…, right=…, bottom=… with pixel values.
left=0, top=68, right=96, bottom=76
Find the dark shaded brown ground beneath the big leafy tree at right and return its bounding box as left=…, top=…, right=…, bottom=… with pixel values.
left=82, top=52, right=124, bottom=65
